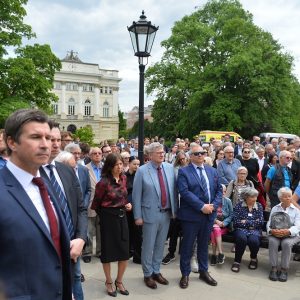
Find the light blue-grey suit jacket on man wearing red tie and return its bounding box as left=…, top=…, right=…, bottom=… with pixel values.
left=132, top=162, right=177, bottom=223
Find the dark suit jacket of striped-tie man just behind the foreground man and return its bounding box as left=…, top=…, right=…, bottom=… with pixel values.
left=40, top=162, right=87, bottom=241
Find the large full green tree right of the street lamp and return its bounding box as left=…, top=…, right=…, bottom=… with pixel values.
left=146, top=0, right=300, bottom=138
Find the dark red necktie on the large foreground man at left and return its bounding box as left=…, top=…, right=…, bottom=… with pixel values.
left=32, top=177, right=61, bottom=257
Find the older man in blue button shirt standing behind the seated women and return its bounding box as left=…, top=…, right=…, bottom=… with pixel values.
left=217, top=146, right=241, bottom=186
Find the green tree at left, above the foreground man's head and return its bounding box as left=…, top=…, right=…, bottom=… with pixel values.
left=0, top=0, right=61, bottom=127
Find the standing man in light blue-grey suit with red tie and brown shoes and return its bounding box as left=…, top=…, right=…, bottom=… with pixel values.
left=132, top=143, right=177, bottom=289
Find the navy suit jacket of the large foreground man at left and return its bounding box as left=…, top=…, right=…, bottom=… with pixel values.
left=0, top=167, right=72, bottom=300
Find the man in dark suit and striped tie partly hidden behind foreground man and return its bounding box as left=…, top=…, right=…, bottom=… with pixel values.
left=40, top=127, right=87, bottom=300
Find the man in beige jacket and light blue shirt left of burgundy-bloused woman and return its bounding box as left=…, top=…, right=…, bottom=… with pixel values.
left=82, top=146, right=103, bottom=263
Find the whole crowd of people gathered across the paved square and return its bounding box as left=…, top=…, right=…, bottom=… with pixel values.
left=0, top=109, right=300, bottom=300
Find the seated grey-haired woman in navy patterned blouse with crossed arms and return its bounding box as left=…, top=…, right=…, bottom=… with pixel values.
left=231, top=187, right=264, bottom=272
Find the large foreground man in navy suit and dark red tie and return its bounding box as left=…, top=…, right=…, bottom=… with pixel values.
left=0, top=109, right=72, bottom=300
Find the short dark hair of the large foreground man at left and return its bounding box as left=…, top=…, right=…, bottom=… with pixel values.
left=4, top=109, right=52, bottom=154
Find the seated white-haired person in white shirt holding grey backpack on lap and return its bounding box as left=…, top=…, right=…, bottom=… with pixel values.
left=267, top=187, right=300, bottom=282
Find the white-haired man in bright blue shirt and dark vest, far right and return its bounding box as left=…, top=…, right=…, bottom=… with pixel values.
left=265, top=150, right=292, bottom=208
